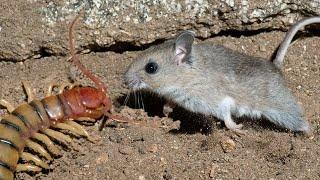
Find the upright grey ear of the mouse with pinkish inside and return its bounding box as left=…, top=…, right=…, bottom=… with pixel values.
left=174, top=31, right=195, bottom=65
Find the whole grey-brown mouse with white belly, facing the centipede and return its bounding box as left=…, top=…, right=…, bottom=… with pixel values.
left=124, top=17, right=320, bottom=134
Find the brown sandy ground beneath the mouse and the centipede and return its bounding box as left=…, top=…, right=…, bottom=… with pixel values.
left=0, top=28, right=320, bottom=180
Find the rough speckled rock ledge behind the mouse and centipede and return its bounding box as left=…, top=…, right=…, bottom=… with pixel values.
left=0, top=0, right=320, bottom=61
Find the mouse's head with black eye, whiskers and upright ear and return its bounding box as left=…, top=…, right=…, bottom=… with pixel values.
left=125, top=31, right=198, bottom=94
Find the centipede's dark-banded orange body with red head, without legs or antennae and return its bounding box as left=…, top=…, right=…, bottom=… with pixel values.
left=0, top=87, right=106, bottom=179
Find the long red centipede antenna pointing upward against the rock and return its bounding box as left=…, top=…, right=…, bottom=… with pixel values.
left=69, top=13, right=108, bottom=93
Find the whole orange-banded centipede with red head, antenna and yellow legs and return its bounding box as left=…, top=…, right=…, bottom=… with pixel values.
left=0, top=14, right=117, bottom=180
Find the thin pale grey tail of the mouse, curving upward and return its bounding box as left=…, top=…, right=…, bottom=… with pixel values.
left=273, top=16, right=320, bottom=69
